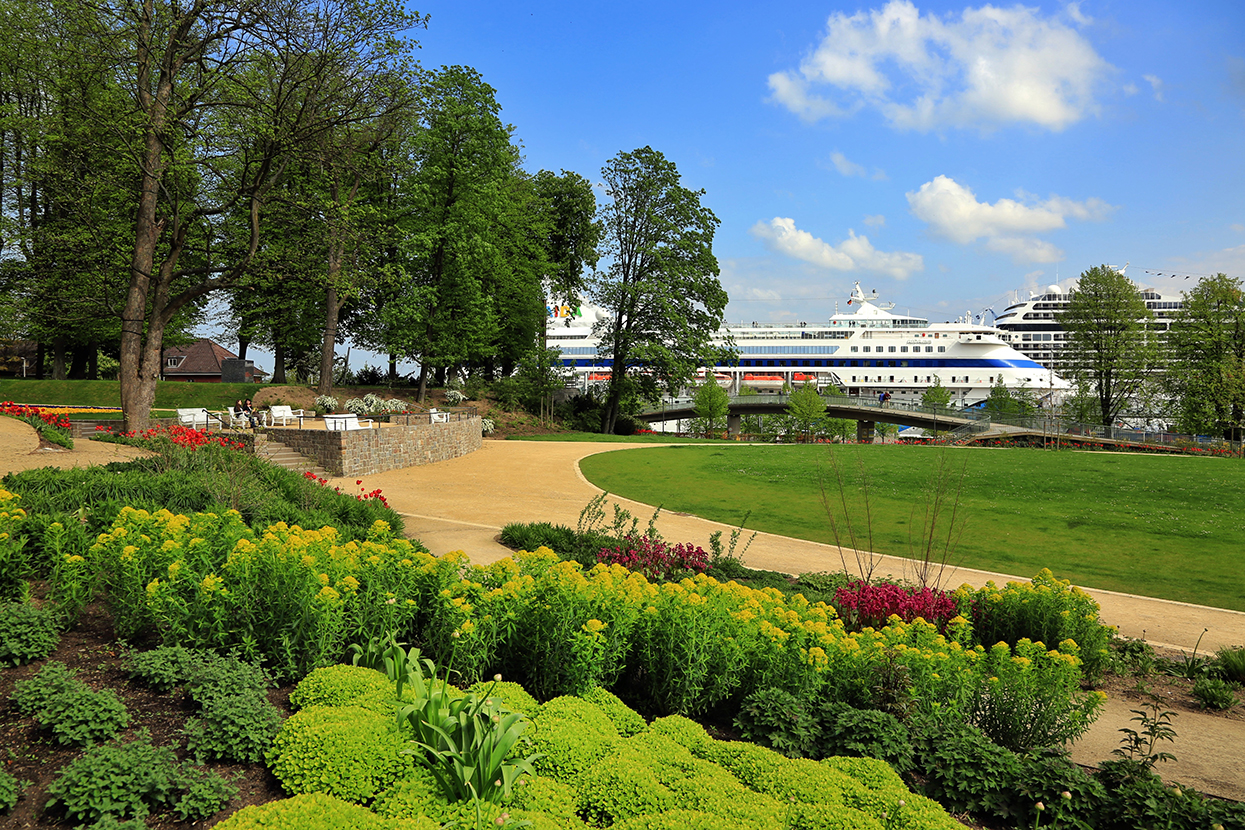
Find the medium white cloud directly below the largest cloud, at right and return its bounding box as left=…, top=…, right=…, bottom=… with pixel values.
left=908, top=175, right=1114, bottom=263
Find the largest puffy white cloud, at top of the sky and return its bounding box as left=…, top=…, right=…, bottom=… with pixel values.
left=769, top=0, right=1112, bottom=132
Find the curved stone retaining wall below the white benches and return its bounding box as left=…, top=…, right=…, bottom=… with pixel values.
left=273, top=416, right=484, bottom=475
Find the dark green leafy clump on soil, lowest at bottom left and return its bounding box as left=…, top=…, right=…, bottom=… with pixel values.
left=47, top=732, right=237, bottom=821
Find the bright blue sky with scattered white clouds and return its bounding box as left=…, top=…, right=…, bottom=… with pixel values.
left=224, top=0, right=1245, bottom=373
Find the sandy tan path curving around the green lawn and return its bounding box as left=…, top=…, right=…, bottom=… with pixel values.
left=332, top=441, right=1245, bottom=800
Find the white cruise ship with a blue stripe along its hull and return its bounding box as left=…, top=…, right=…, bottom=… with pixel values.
left=547, top=282, right=1069, bottom=407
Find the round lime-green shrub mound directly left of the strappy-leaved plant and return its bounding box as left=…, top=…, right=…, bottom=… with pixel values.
left=266, top=706, right=412, bottom=803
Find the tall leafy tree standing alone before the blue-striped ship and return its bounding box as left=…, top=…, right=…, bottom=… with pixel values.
left=590, top=147, right=728, bottom=434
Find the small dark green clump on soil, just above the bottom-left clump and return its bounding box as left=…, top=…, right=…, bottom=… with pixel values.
left=12, top=661, right=129, bottom=745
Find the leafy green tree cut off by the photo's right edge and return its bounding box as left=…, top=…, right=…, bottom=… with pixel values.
left=1167, top=274, right=1245, bottom=441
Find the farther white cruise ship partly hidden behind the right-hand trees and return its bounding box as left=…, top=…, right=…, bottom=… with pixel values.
left=994, top=277, right=1183, bottom=375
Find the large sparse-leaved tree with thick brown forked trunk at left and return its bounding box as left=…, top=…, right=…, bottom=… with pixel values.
left=8, top=0, right=425, bottom=428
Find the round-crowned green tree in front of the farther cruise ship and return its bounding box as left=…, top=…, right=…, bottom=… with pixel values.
left=1063, top=265, right=1160, bottom=426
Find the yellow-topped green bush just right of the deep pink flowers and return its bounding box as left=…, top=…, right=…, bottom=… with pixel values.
left=956, top=569, right=1114, bottom=681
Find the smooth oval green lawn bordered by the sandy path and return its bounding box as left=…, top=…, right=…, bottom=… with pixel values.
left=580, top=444, right=1245, bottom=611
